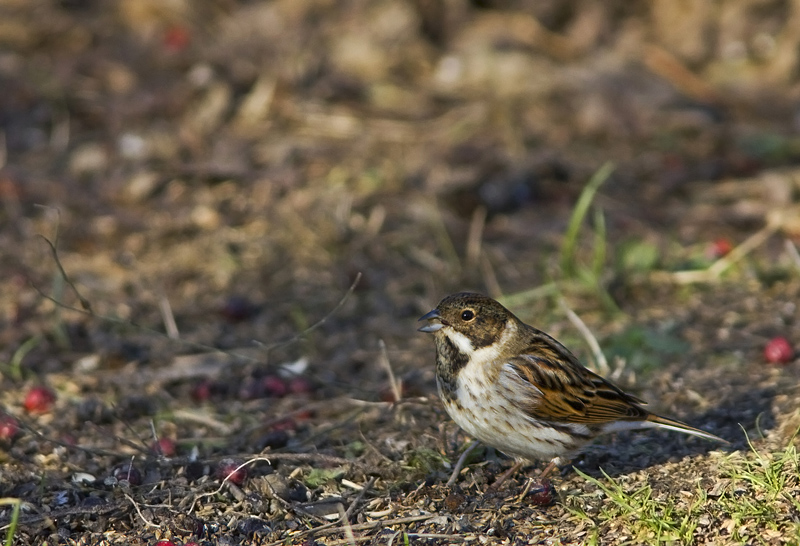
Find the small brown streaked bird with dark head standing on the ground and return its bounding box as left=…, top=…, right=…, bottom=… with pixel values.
left=420, top=292, right=727, bottom=483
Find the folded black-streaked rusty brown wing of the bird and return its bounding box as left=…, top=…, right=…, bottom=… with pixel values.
left=499, top=331, right=650, bottom=425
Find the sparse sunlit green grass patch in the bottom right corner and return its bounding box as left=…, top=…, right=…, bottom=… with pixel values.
left=569, top=439, right=800, bottom=545
